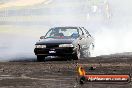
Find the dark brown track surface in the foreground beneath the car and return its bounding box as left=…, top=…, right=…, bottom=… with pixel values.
left=0, top=56, right=132, bottom=88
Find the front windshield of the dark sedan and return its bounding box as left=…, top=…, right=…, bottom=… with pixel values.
left=45, top=27, right=79, bottom=39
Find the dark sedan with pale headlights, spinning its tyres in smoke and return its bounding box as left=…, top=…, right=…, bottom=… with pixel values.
left=34, top=27, right=94, bottom=61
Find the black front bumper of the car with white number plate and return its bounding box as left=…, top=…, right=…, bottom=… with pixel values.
left=34, top=47, right=76, bottom=56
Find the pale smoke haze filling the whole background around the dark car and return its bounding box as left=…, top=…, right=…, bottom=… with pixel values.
left=0, top=0, right=132, bottom=60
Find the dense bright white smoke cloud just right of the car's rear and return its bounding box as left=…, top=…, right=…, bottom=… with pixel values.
left=94, top=28, right=132, bottom=56
